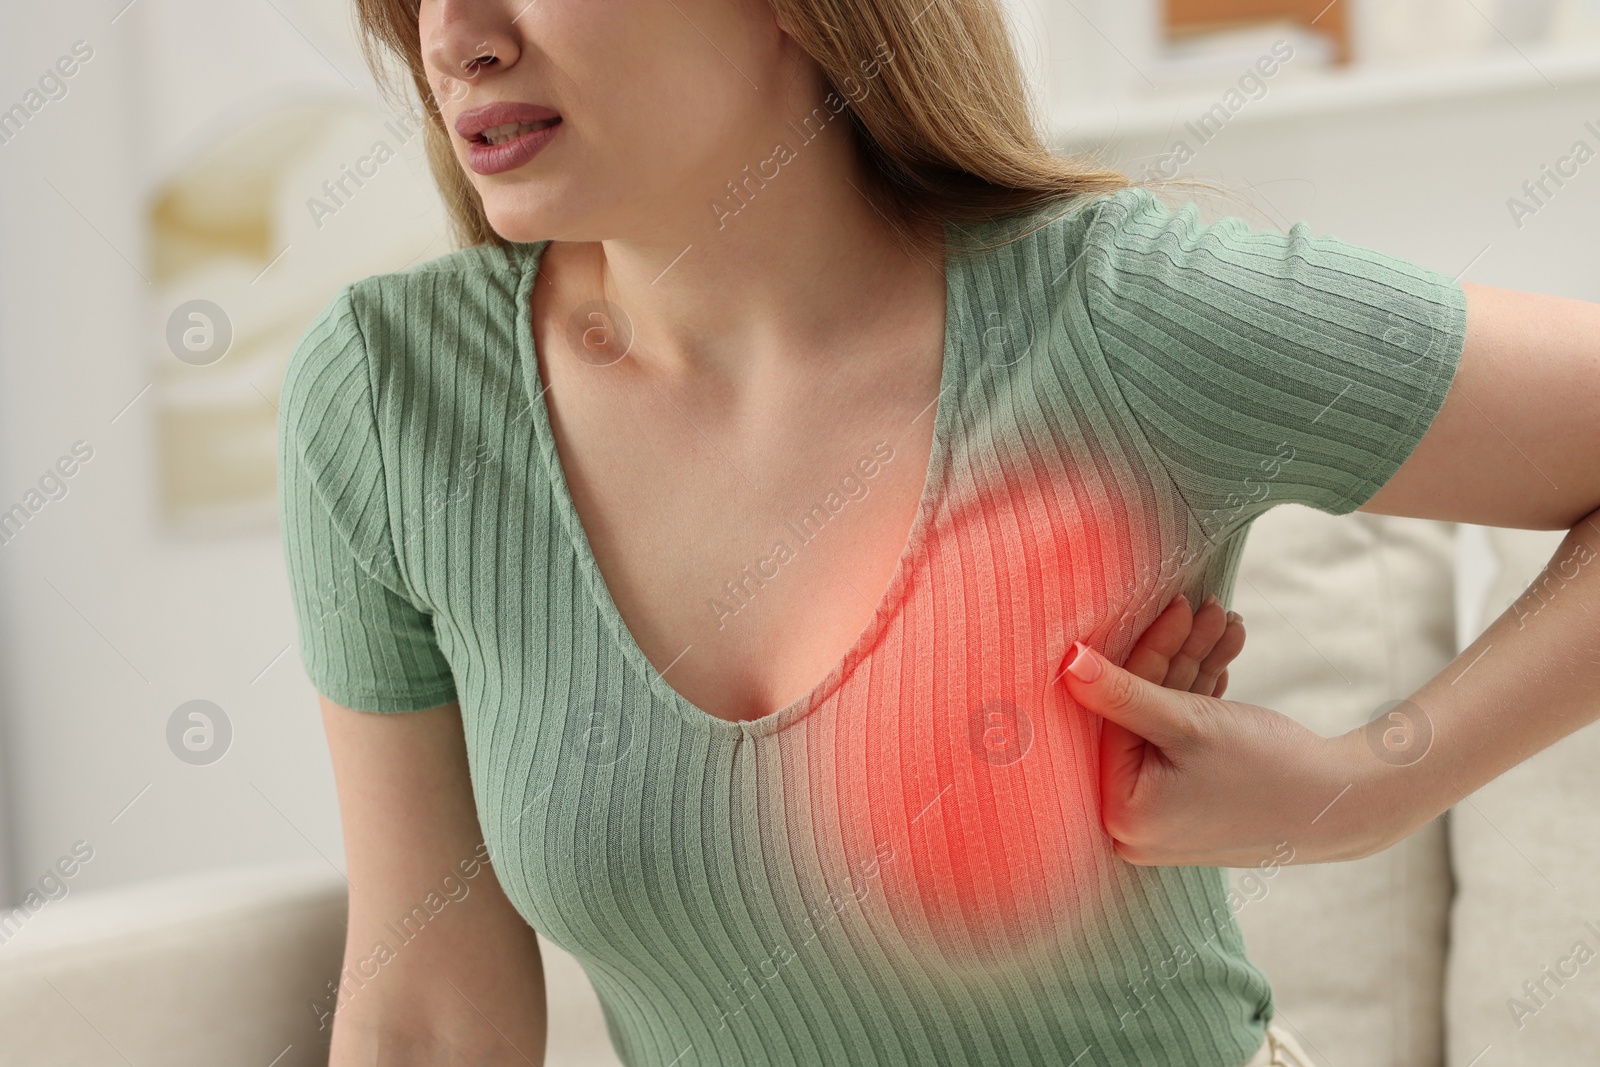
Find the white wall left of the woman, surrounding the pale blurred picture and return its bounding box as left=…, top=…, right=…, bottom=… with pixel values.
left=0, top=0, right=446, bottom=901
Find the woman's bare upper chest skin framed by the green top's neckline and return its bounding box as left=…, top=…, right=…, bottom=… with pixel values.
left=541, top=307, right=944, bottom=720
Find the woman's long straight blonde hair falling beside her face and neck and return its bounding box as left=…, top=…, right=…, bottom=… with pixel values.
left=355, top=0, right=1190, bottom=255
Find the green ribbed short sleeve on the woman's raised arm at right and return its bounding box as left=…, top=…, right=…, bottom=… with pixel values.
left=1082, top=187, right=1467, bottom=536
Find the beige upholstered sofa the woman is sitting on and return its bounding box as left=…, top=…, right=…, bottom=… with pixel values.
left=0, top=506, right=1574, bottom=1067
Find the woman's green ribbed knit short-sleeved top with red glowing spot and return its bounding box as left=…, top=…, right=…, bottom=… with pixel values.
left=280, top=189, right=1466, bottom=1067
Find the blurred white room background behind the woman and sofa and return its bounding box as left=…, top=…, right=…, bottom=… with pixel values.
left=0, top=0, right=1600, bottom=1067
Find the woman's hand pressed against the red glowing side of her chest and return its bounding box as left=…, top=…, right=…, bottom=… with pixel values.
left=1064, top=600, right=1389, bottom=867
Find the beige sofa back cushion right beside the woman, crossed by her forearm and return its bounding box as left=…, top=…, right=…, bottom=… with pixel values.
left=1226, top=504, right=1464, bottom=1067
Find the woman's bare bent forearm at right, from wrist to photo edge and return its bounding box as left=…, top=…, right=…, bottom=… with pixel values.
left=1346, top=510, right=1600, bottom=851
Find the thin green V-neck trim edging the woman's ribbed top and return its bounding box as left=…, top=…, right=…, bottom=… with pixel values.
left=515, top=224, right=971, bottom=737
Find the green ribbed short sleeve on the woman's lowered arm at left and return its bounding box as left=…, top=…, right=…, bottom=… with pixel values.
left=278, top=286, right=456, bottom=712
